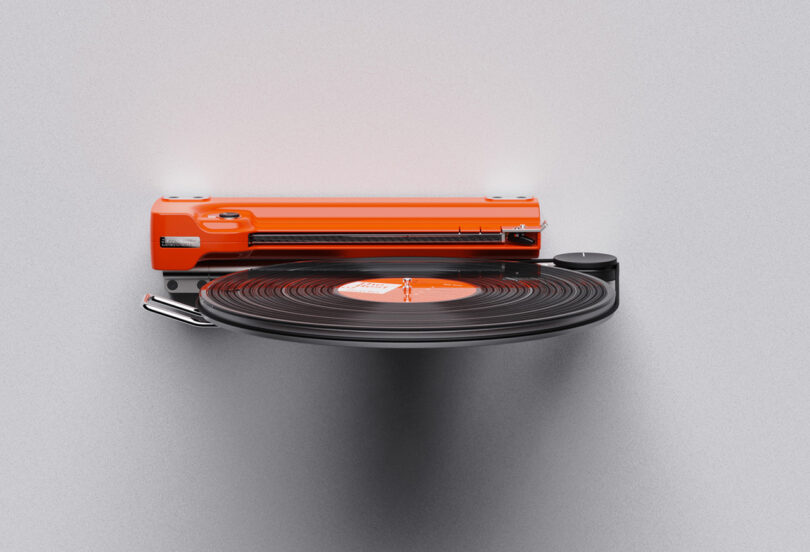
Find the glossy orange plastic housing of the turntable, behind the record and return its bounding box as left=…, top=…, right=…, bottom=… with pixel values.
left=151, top=197, right=541, bottom=271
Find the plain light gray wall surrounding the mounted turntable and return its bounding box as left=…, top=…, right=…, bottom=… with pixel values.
left=0, top=2, right=810, bottom=551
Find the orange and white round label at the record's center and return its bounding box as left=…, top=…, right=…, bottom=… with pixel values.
left=337, top=278, right=478, bottom=303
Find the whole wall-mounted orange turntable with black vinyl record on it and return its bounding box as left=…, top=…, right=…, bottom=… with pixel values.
left=143, top=195, right=619, bottom=347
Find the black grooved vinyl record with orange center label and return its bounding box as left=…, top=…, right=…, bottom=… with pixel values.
left=198, top=258, right=617, bottom=347
